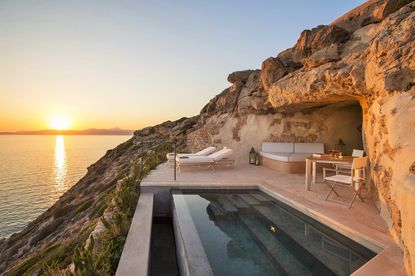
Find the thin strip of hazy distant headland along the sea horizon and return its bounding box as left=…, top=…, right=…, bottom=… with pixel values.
left=0, top=127, right=134, bottom=135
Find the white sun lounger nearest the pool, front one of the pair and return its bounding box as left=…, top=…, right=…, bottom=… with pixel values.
left=176, top=149, right=234, bottom=171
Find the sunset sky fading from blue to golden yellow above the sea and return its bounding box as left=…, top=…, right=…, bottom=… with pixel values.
left=0, top=0, right=363, bottom=131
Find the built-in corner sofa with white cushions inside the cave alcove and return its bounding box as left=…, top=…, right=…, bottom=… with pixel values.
left=259, top=142, right=324, bottom=173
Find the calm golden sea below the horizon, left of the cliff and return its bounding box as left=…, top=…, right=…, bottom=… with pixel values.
left=0, top=135, right=130, bottom=238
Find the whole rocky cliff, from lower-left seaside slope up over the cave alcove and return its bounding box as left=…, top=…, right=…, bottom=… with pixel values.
left=0, top=0, right=415, bottom=274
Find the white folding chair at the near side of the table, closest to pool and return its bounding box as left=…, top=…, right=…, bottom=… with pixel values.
left=323, top=156, right=367, bottom=209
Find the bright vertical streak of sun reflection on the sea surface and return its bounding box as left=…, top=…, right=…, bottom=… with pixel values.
left=54, top=135, right=67, bottom=193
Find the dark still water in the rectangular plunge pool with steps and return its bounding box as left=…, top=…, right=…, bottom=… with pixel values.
left=172, top=190, right=376, bottom=275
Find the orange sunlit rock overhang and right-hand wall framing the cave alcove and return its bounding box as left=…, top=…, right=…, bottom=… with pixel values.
left=261, top=1, right=415, bottom=273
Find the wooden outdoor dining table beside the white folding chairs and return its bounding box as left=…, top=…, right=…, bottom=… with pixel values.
left=305, top=154, right=353, bottom=191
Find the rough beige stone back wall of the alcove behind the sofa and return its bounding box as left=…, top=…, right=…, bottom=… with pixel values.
left=187, top=104, right=363, bottom=163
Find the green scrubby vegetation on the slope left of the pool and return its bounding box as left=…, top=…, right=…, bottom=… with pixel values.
left=8, top=143, right=172, bottom=275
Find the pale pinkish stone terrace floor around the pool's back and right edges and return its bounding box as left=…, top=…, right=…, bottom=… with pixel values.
left=141, top=164, right=405, bottom=275
